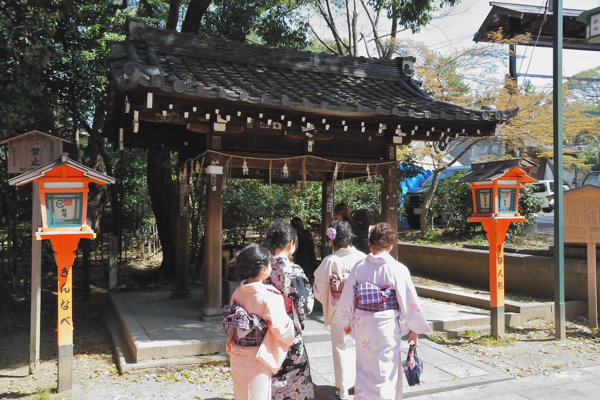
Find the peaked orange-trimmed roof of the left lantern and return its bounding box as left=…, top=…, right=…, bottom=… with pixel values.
left=8, top=153, right=115, bottom=186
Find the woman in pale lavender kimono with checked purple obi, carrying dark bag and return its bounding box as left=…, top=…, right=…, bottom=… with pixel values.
left=335, top=222, right=429, bottom=400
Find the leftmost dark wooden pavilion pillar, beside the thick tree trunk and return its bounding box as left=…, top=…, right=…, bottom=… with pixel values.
left=171, top=161, right=190, bottom=298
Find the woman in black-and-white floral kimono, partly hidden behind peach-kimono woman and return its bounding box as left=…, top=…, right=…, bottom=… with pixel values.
left=265, top=220, right=315, bottom=400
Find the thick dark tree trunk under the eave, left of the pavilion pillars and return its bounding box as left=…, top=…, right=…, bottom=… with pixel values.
left=147, top=149, right=179, bottom=279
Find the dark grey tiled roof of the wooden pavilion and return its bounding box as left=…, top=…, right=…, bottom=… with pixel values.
left=110, top=19, right=518, bottom=123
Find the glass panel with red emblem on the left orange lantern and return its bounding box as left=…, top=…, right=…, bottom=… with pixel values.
left=46, top=193, right=83, bottom=228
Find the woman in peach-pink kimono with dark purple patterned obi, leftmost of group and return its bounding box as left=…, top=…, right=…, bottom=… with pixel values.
left=223, top=244, right=294, bottom=400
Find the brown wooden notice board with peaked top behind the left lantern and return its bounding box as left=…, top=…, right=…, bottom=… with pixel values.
left=0, top=131, right=67, bottom=174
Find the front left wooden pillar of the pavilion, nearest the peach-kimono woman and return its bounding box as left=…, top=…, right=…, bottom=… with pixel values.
left=201, top=167, right=223, bottom=321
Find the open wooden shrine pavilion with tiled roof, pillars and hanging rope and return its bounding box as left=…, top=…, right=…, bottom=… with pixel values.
left=104, top=18, right=518, bottom=319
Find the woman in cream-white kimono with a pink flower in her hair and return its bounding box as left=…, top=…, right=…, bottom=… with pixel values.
left=313, top=221, right=367, bottom=399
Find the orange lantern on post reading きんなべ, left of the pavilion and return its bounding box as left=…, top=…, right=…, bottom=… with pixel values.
left=8, top=154, right=115, bottom=391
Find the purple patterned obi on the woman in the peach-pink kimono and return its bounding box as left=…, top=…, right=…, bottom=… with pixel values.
left=221, top=300, right=269, bottom=346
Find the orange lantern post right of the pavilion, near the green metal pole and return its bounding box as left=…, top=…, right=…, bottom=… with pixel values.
left=457, top=159, right=536, bottom=339
